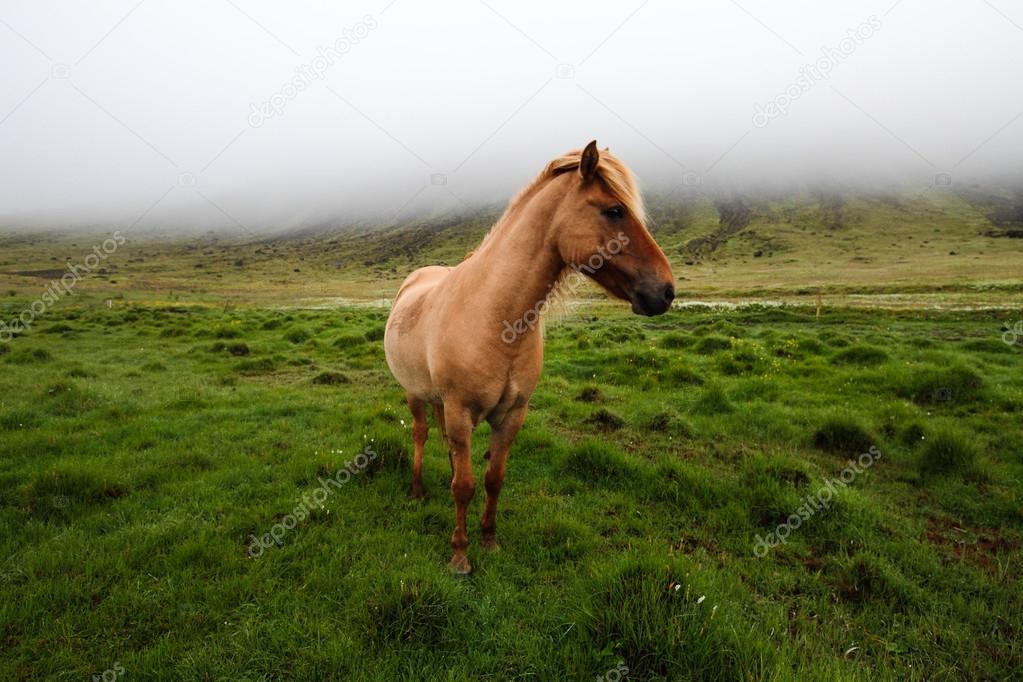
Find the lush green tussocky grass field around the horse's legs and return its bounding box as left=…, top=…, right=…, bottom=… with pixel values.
left=0, top=301, right=1023, bottom=680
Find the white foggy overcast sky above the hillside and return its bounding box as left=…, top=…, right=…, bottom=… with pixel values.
left=0, top=0, right=1023, bottom=229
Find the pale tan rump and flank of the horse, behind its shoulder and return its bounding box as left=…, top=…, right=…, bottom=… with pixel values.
left=384, top=266, right=451, bottom=400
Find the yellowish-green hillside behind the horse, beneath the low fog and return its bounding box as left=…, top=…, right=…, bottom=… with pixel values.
left=0, top=190, right=1023, bottom=306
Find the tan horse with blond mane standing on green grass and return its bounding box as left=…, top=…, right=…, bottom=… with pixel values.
left=384, top=142, right=675, bottom=574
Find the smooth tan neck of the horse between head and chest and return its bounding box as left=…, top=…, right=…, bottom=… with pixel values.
left=465, top=187, right=565, bottom=334
